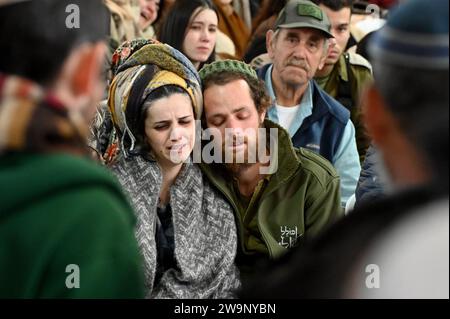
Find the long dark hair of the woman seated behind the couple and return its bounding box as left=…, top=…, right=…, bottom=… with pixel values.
left=157, top=0, right=219, bottom=69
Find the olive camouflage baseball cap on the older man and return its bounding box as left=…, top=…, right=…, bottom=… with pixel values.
left=275, top=0, right=333, bottom=38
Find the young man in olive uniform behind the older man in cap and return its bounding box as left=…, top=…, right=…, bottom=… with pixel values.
left=313, top=0, right=373, bottom=160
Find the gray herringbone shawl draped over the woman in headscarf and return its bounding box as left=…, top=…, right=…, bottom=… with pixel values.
left=112, top=156, right=240, bottom=298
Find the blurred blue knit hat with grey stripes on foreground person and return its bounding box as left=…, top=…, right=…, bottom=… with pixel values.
left=369, top=0, right=449, bottom=69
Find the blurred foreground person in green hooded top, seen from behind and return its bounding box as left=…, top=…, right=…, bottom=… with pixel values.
left=0, top=0, right=143, bottom=298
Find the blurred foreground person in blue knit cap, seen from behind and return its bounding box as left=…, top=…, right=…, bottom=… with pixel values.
left=244, top=0, right=449, bottom=299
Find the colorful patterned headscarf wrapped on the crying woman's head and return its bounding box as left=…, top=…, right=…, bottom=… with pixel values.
left=108, top=39, right=203, bottom=157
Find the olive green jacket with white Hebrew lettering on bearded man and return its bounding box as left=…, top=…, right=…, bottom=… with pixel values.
left=201, top=120, right=343, bottom=266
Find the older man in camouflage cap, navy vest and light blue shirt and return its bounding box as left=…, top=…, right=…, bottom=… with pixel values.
left=258, top=0, right=361, bottom=205
